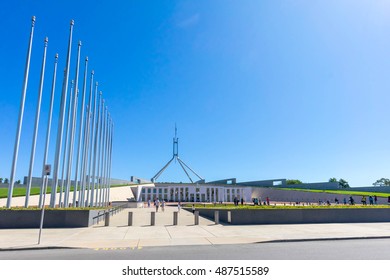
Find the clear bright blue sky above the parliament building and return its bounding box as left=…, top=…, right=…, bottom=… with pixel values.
left=0, top=0, right=390, bottom=187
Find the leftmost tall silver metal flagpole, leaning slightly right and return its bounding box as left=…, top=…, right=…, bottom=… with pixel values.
left=7, top=16, right=35, bottom=208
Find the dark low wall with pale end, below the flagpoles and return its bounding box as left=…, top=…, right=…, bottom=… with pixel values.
left=0, top=210, right=103, bottom=228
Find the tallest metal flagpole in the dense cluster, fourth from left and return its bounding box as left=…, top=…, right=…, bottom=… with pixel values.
left=50, top=20, right=74, bottom=207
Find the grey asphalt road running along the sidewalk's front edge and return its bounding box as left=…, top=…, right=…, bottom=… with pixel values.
left=0, top=239, right=390, bottom=260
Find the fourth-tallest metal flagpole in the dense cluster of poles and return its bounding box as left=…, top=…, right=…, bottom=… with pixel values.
left=79, top=70, right=94, bottom=207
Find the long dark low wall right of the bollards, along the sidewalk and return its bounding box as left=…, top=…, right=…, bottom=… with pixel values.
left=196, top=208, right=390, bottom=225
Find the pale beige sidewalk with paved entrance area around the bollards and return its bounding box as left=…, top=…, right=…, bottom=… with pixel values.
left=0, top=206, right=390, bottom=250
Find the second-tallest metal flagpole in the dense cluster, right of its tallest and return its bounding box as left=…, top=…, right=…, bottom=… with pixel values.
left=64, top=41, right=81, bottom=207
